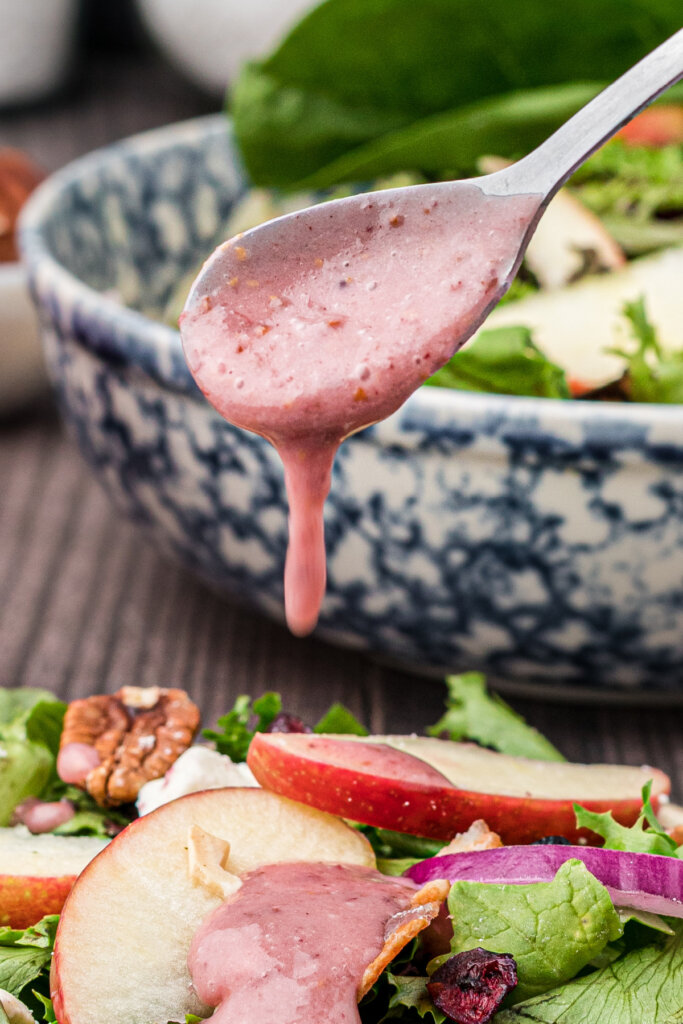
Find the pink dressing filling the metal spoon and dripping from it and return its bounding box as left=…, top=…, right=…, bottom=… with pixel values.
left=180, top=184, right=542, bottom=635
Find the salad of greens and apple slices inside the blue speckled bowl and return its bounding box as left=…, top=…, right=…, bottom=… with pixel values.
left=161, top=0, right=683, bottom=403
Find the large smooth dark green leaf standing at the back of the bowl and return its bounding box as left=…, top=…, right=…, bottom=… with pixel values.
left=230, top=0, right=680, bottom=187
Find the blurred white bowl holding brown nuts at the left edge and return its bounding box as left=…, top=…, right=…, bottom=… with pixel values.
left=0, top=263, right=47, bottom=415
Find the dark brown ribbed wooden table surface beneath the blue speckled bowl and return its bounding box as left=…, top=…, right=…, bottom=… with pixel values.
left=0, top=55, right=683, bottom=799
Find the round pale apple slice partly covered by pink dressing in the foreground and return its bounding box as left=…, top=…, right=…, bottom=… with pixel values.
left=51, top=787, right=375, bottom=1024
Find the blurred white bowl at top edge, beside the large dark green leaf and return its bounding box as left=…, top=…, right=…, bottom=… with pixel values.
left=137, top=0, right=314, bottom=95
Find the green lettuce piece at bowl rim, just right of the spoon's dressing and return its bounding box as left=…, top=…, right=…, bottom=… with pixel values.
left=427, top=327, right=571, bottom=398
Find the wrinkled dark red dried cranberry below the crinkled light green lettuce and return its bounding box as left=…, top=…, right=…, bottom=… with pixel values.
left=427, top=949, right=517, bottom=1024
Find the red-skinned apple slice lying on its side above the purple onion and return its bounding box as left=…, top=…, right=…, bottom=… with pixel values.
left=247, top=733, right=670, bottom=843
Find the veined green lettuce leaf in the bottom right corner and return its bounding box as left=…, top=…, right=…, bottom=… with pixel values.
left=494, top=922, right=683, bottom=1024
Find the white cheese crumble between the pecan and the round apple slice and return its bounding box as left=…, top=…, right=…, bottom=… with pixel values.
left=136, top=746, right=258, bottom=814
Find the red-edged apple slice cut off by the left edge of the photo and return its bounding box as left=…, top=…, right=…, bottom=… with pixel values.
left=0, top=825, right=109, bottom=928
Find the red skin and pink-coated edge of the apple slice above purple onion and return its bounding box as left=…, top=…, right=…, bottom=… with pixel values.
left=247, top=733, right=669, bottom=845
